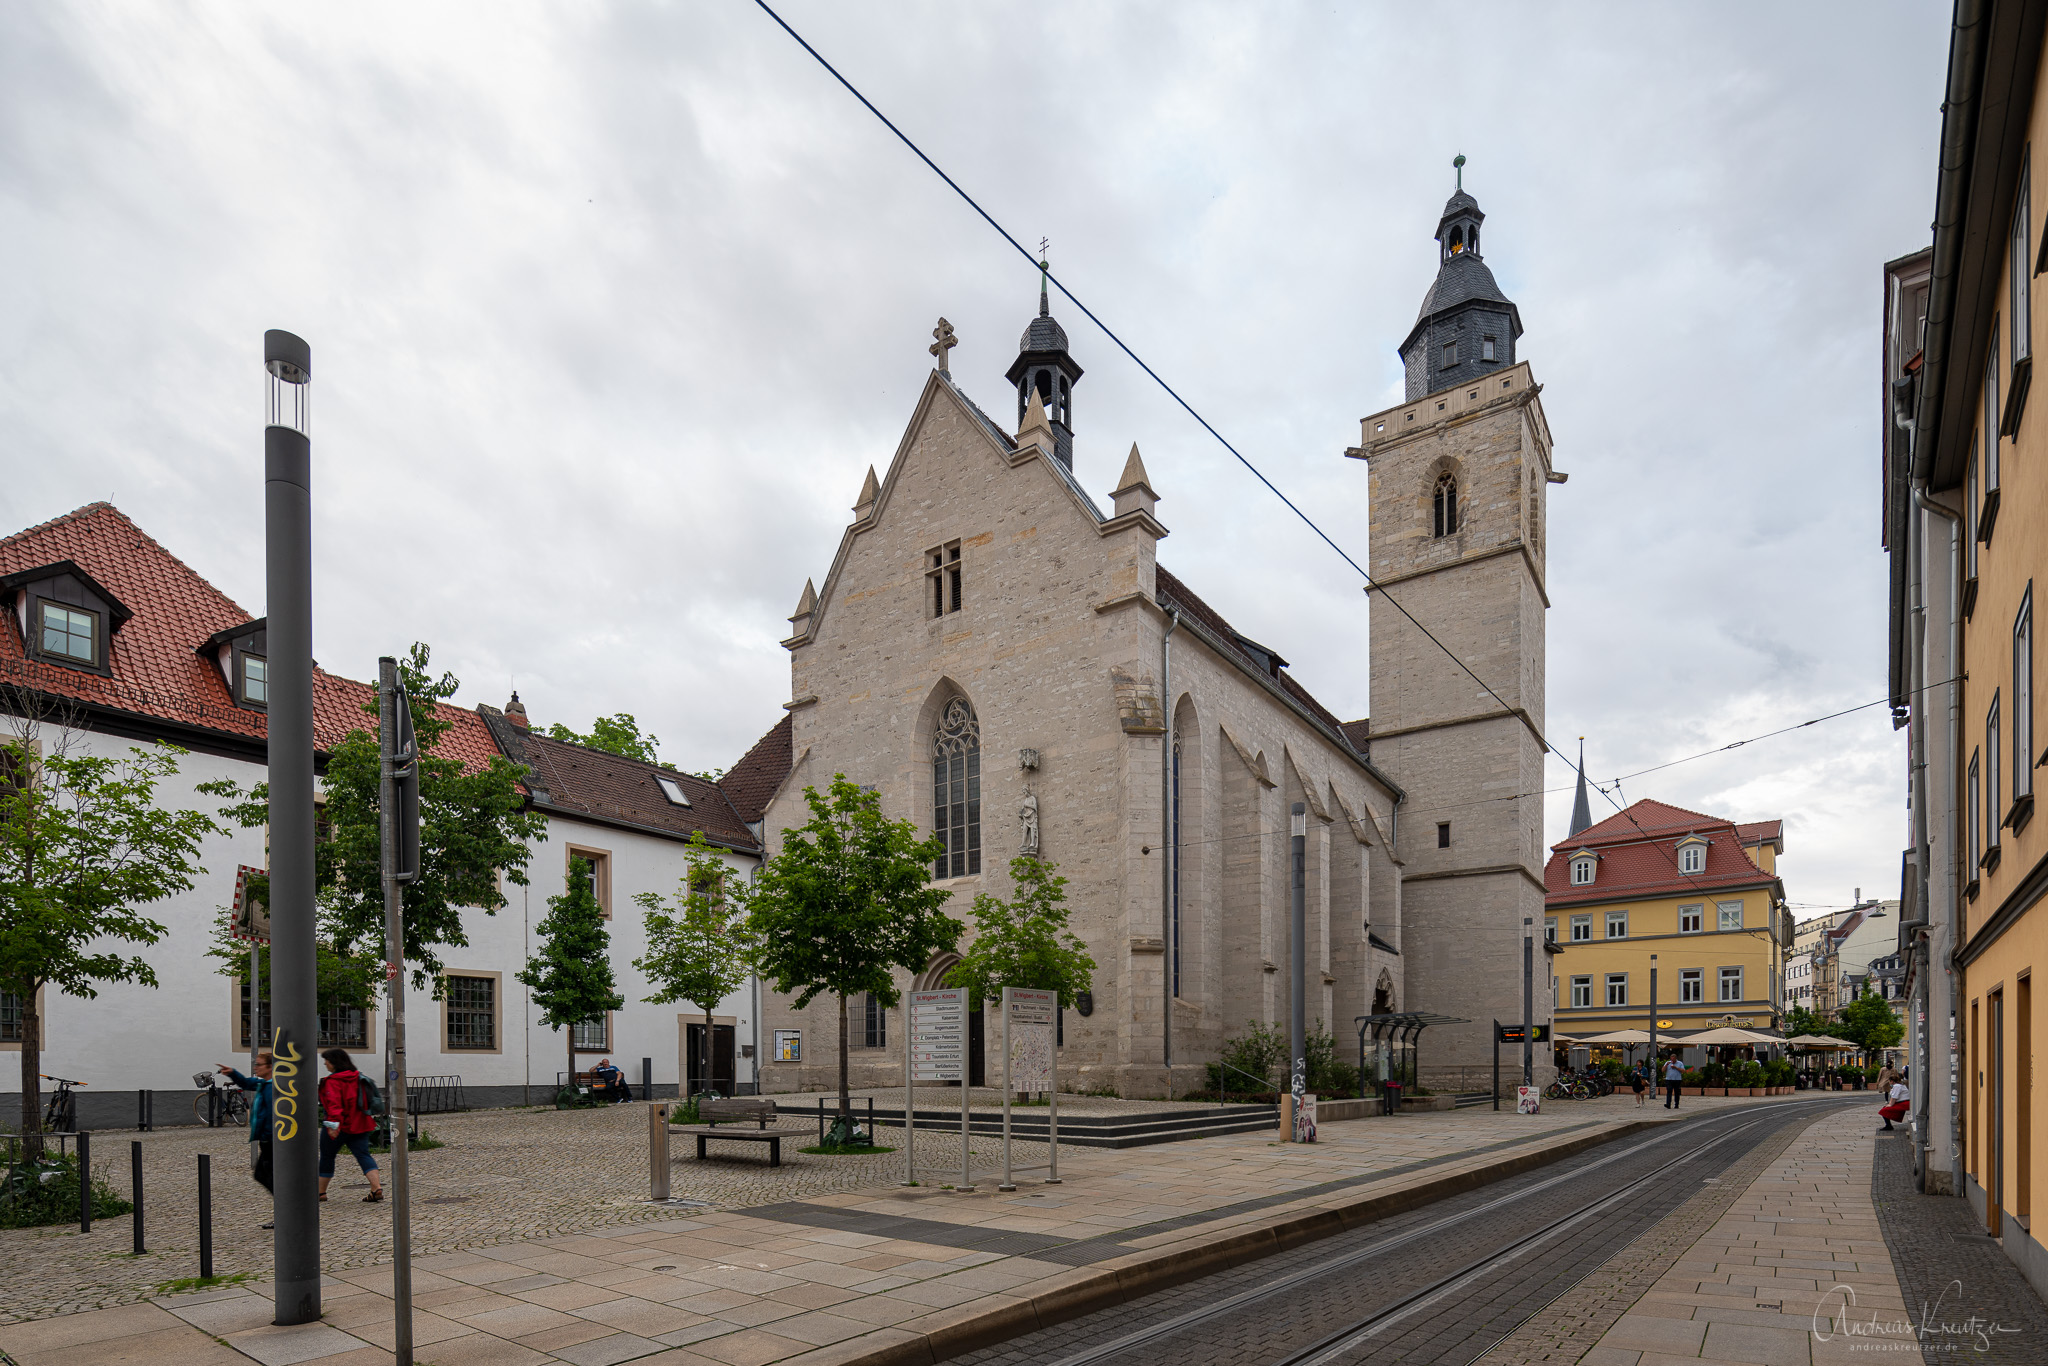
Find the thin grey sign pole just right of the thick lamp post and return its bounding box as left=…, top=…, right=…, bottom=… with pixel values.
left=377, top=655, right=420, bottom=1366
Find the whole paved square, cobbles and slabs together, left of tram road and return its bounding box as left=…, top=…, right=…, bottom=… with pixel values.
left=0, top=1098, right=1786, bottom=1366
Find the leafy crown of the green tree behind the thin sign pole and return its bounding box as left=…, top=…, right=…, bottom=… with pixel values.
left=201, top=643, right=547, bottom=987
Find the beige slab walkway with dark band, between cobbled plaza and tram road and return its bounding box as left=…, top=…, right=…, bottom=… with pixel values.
left=0, top=1096, right=1794, bottom=1366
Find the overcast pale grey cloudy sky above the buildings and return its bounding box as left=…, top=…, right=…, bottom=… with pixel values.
left=0, top=0, right=1948, bottom=915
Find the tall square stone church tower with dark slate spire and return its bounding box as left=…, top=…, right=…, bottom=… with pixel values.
left=1346, top=167, right=1565, bottom=1092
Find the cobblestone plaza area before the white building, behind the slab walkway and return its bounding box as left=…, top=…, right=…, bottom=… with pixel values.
left=0, top=1106, right=1047, bottom=1323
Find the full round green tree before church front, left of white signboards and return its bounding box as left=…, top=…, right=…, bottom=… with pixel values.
left=731, top=774, right=961, bottom=1128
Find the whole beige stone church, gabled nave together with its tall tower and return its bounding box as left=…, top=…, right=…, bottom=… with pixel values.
left=733, top=188, right=1563, bottom=1098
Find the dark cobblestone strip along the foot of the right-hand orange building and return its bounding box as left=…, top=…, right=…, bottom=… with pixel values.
left=1870, top=1128, right=2048, bottom=1366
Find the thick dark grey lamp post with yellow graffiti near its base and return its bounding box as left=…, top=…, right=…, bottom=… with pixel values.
left=264, top=330, right=319, bottom=1325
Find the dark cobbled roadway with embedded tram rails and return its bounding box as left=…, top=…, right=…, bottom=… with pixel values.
left=958, top=1108, right=1867, bottom=1366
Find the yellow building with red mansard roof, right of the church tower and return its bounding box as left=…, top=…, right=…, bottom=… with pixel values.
left=1544, top=801, right=1792, bottom=1042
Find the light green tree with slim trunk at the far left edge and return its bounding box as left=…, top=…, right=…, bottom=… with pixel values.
left=0, top=724, right=223, bottom=1157
